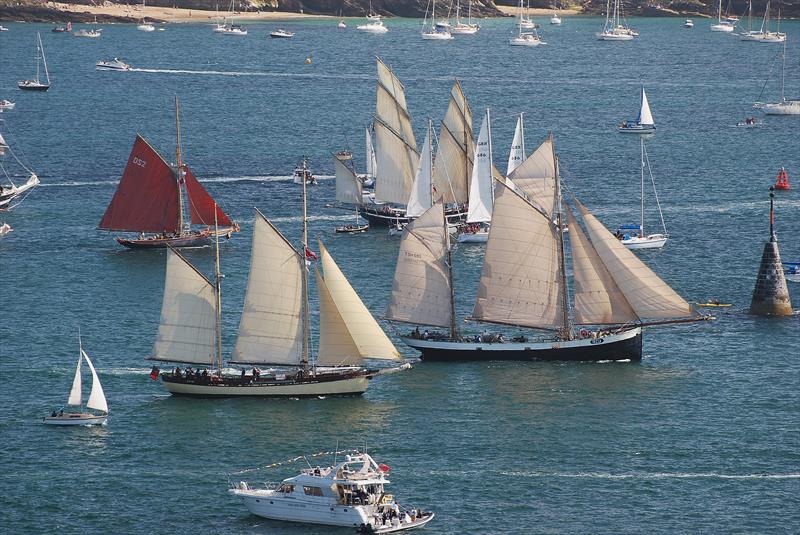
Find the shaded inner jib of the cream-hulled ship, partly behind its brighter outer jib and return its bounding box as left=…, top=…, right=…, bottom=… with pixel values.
left=316, top=271, right=361, bottom=366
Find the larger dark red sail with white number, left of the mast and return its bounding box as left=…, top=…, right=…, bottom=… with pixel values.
left=99, top=135, right=180, bottom=233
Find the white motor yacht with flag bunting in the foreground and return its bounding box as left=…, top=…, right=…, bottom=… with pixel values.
left=228, top=452, right=435, bottom=533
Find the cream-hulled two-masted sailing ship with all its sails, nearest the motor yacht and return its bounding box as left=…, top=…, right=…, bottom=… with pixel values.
left=151, top=179, right=400, bottom=397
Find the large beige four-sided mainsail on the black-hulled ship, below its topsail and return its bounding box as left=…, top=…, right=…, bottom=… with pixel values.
left=472, top=183, right=563, bottom=330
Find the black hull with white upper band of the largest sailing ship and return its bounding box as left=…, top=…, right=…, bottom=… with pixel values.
left=403, top=327, right=642, bottom=362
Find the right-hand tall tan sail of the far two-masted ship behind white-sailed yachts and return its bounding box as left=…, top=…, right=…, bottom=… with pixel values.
left=433, top=80, right=475, bottom=203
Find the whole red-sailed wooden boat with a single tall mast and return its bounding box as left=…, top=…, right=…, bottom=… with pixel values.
left=98, top=97, right=239, bottom=249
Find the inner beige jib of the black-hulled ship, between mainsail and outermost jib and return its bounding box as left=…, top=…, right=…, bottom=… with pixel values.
left=565, top=205, right=639, bottom=325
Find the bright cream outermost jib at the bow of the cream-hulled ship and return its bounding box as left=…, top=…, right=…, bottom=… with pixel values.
left=319, top=242, right=400, bottom=360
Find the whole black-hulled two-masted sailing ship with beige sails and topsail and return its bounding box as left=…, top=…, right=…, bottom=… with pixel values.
left=387, top=136, right=705, bottom=361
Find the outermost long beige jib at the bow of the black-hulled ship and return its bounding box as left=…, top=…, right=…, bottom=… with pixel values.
left=578, top=203, right=695, bottom=320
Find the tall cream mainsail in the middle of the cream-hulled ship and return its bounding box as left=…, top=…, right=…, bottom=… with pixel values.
left=231, top=211, right=305, bottom=365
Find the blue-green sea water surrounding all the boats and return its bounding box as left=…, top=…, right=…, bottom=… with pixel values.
left=0, top=17, right=800, bottom=534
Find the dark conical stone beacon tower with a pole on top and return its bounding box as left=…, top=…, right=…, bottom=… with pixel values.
left=750, top=186, right=792, bottom=316
